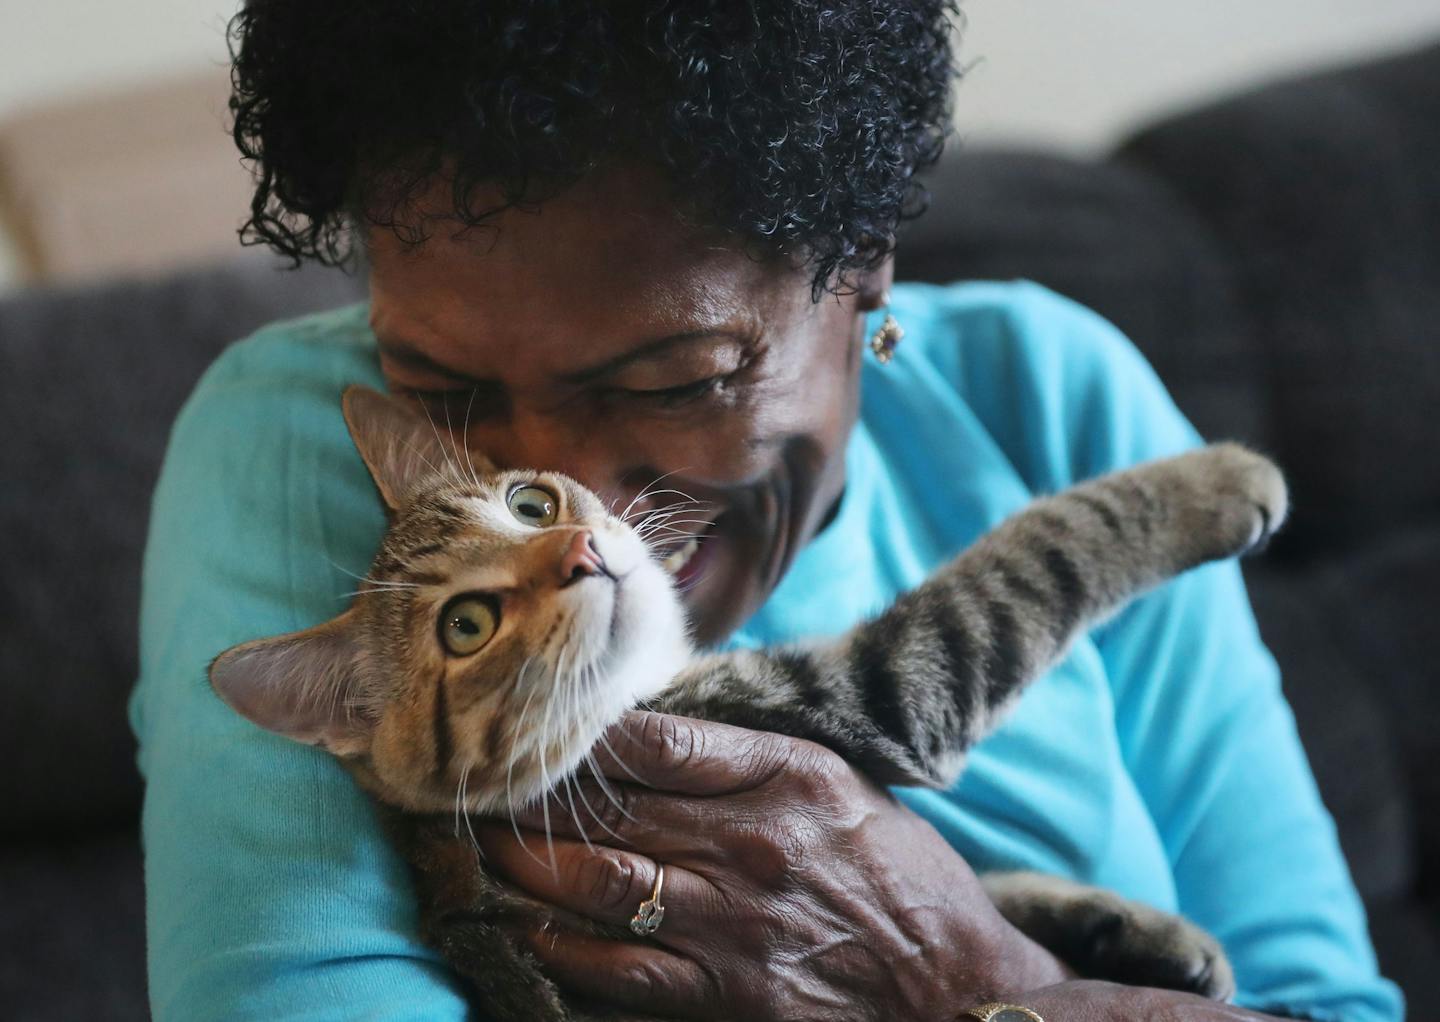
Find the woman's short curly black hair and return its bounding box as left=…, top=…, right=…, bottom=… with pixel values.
left=230, top=0, right=958, bottom=299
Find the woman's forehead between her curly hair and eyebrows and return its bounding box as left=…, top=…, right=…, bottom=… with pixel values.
left=367, top=174, right=789, bottom=370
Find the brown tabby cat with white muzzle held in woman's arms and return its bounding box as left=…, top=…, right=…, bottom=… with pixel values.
left=210, top=387, right=1286, bottom=1022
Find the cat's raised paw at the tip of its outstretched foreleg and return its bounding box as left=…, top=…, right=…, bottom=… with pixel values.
left=1188, top=443, right=1290, bottom=556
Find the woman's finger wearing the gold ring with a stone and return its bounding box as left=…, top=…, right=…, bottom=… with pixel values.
left=478, top=825, right=723, bottom=949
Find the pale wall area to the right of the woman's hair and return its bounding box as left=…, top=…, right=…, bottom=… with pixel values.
left=958, top=0, right=1440, bottom=153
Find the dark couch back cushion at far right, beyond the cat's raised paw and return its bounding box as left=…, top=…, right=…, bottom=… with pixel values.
left=1119, top=46, right=1440, bottom=553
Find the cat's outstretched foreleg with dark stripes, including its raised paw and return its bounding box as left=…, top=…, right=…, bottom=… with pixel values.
left=655, top=445, right=1286, bottom=787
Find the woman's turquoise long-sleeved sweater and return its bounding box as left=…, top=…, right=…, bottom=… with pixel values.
left=131, top=284, right=1401, bottom=1022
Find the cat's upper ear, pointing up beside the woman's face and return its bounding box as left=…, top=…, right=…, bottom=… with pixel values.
left=341, top=386, right=492, bottom=511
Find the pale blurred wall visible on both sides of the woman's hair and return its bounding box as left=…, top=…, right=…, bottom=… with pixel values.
left=0, top=0, right=1440, bottom=288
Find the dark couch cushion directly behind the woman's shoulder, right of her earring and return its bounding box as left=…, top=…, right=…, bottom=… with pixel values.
left=896, top=150, right=1269, bottom=445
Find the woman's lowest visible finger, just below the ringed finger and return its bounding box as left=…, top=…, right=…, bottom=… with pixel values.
left=524, top=927, right=721, bottom=1019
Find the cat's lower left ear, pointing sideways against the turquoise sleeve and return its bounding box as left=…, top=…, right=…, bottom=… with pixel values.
left=210, top=610, right=370, bottom=756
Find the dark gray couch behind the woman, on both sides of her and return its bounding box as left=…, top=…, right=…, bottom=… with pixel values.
left=0, top=48, right=1440, bottom=1022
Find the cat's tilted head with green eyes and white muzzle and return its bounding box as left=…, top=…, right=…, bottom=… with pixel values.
left=210, top=387, right=693, bottom=812
